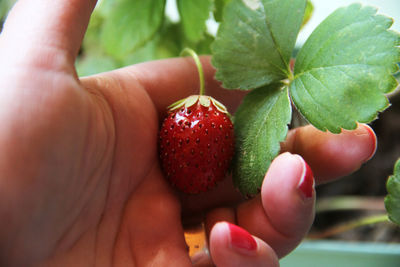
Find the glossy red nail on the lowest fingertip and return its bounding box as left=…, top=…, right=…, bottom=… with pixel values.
left=227, top=223, right=257, bottom=254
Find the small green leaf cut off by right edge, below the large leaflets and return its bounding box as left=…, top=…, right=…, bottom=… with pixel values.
left=385, top=159, right=400, bottom=225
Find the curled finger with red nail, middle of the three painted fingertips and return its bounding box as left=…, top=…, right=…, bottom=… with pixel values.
left=236, top=153, right=315, bottom=257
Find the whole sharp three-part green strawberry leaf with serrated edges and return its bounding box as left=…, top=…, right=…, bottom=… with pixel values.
left=212, top=0, right=400, bottom=195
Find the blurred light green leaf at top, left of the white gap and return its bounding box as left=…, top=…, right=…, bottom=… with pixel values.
left=102, top=0, right=165, bottom=59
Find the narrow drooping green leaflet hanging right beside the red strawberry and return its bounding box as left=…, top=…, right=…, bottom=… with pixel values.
left=233, top=84, right=291, bottom=196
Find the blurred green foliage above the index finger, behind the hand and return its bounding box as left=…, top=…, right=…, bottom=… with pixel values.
left=76, top=0, right=225, bottom=76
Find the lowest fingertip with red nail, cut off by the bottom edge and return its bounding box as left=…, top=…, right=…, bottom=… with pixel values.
left=210, top=222, right=279, bottom=267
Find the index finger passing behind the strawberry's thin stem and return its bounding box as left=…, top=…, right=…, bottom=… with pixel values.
left=82, top=56, right=244, bottom=113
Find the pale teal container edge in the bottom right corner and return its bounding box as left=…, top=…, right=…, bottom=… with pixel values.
left=280, top=241, right=400, bottom=267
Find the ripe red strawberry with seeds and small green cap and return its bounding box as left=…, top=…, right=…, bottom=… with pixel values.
left=159, top=95, right=234, bottom=194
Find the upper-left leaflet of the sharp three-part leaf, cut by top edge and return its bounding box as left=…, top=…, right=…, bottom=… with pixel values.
left=212, top=0, right=306, bottom=89
